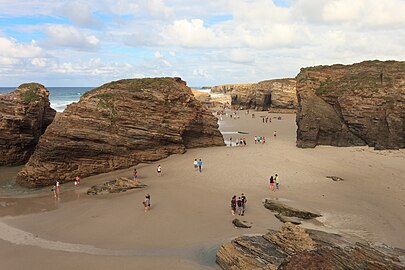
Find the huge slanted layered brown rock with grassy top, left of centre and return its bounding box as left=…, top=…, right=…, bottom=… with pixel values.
left=17, top=78, right=224, bottom=187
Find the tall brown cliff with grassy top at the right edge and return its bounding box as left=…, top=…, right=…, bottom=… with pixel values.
left=296, top=61, right=405, bottom=149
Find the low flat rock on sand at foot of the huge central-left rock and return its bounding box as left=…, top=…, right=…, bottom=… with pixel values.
left=87, top=177, right=147, bottom=195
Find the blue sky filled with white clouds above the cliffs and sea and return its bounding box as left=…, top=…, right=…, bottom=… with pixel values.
left=0, top=0, right=405, bottom=87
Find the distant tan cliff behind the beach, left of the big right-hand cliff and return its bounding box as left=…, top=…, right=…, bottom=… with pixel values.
left=231, top=79, right=297, bottom=110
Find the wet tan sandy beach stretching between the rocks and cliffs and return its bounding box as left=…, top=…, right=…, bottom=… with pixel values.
left=0, top=111, right=405, bottom=269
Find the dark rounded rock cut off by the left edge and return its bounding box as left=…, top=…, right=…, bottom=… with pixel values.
left=0, top=83, right=56, bottom=165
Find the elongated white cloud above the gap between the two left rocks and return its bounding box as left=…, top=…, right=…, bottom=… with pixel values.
left=44, top=25, right=100, bottom=51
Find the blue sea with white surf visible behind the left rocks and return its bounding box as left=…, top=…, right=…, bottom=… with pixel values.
left=0, top=87, right=95, bottom=112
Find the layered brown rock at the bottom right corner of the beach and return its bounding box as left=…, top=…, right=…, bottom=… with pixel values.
left=217, top=223, right=405, bottom=270
